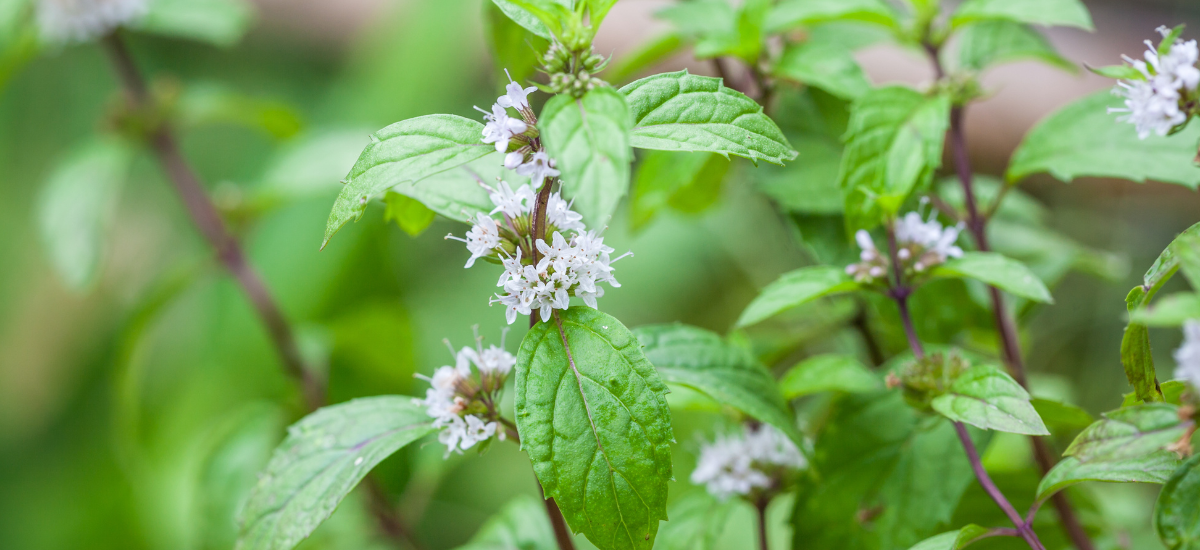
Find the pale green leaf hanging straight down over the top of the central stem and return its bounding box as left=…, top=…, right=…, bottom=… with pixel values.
left=538, top=88, right=632, bottom=227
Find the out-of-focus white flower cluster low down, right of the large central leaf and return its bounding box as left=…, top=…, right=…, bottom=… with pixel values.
left=691, top=425, right=808, bottom=501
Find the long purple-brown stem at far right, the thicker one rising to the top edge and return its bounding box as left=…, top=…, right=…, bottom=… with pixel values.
left=925, top=44, right=1096, bottom=550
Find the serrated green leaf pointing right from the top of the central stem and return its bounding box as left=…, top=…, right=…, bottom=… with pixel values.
left=620, top=71, right=796, bottom=165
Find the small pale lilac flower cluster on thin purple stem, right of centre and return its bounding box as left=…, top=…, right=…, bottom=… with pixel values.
left=846, top=208, right=962, bottom=283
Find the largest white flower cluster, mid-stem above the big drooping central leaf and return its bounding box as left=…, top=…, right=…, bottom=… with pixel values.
left=446, top=177, right=628, bottom=324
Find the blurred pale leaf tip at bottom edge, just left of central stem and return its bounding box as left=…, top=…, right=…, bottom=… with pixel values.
left=458, top=495, right=558, bottom=550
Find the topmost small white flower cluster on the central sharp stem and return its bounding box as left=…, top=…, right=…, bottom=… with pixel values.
left=475, top=71, right=559, bottom=183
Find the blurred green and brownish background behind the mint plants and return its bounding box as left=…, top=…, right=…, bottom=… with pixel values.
left=7, top=0, right=1200, bottom=550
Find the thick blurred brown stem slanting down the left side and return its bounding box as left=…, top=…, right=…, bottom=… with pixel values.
left=103, top=32, right=424, bottom=550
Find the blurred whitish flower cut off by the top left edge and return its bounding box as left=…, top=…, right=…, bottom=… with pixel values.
left=37, top=0, right=148, bottom=43
